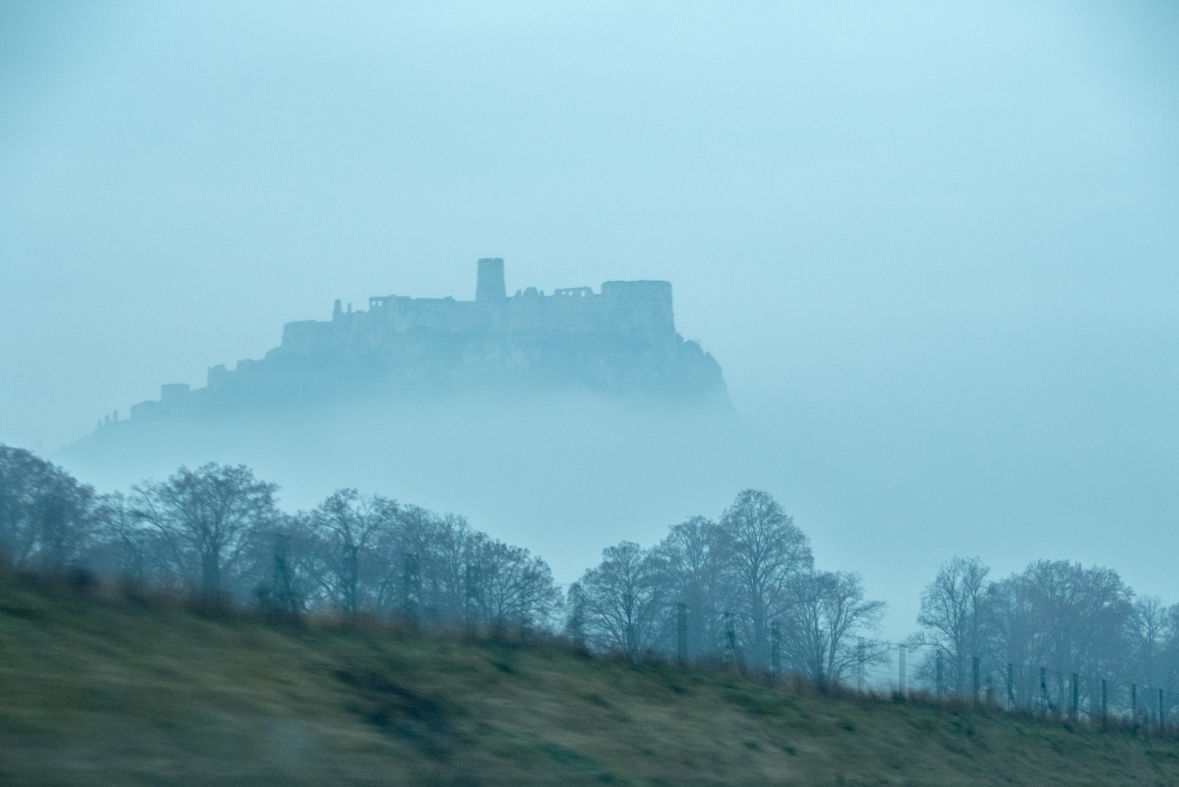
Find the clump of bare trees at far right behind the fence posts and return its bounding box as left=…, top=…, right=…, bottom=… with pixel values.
left=915, top=557, right=1179, bottom=709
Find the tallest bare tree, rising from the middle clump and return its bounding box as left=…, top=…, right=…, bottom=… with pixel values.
left=720, top=489, right=815, bottom=663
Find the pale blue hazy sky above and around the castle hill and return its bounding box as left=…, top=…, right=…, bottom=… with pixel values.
left=0, top=0, right=1179, bottom=631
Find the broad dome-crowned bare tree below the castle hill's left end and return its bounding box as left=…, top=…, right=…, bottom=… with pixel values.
left=133, top=463, right=277, bottom=598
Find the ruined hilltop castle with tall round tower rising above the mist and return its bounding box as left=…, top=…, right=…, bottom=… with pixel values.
left=114, top=258, right=729, bottom=426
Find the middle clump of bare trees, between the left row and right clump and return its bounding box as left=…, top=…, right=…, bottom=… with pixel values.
left=567, top=490, right=885, bottom=682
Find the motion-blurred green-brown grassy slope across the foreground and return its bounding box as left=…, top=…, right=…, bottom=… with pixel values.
left=0, top=574, right=1179, bottom=785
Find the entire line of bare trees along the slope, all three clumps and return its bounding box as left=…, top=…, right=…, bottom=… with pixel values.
left=0, top=445, right=1179, bottom=714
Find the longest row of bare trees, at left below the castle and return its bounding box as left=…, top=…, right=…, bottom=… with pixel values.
left=0, top=445, right=562, bottom=627
